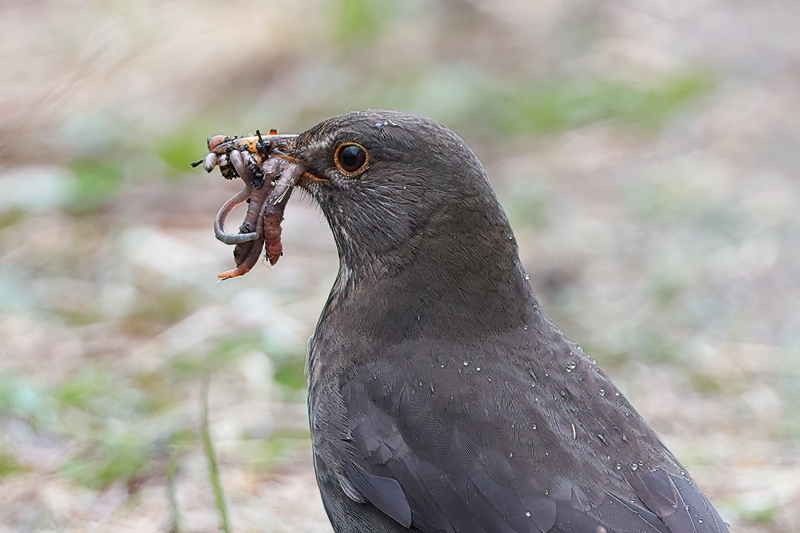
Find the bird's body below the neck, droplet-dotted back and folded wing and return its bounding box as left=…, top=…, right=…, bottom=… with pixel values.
left=309, top=294, right=727, bottom=533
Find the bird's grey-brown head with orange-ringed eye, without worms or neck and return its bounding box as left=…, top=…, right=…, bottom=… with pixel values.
left=289, top=107, right=516, bottom=274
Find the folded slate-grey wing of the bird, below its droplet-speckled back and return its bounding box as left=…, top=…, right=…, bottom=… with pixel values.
left=334, top=350, right=727, bottom=533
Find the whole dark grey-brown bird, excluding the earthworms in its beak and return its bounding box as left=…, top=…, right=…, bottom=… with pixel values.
left=250, top=110, right=729, bottom=533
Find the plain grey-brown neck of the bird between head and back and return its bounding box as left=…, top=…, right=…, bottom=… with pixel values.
left=320, top=200, right=539, bottom=343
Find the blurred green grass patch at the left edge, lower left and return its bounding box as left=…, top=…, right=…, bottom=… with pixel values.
left=0, top=364, right=181, bottom=489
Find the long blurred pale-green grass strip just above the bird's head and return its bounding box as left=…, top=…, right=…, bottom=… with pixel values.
left=332, top=63, right=718, bottom=138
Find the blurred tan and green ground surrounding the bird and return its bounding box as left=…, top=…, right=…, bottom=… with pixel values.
left=0, top=0, right=800, bottom=532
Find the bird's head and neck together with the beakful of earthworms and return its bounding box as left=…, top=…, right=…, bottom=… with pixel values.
left=203, top=111, right=534, bottom=338
